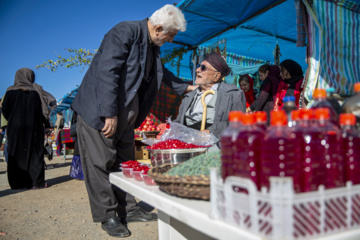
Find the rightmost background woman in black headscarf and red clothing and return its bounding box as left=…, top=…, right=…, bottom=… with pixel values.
left=274, top=59, right=304, bottom=110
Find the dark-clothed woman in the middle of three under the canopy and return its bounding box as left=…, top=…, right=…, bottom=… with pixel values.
left=246, top=64, right=281, bottom=123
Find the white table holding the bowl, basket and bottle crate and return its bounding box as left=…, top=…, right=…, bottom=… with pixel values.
left=110, top=172, right=360, bottom=240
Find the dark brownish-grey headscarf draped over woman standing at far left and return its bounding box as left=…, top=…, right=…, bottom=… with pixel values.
left=6, top=68, right=56, bottom=119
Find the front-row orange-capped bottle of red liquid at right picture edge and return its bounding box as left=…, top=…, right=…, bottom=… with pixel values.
left=340, top=113, right=360, bottom=184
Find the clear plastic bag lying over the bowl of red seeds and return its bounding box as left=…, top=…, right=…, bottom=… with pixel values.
left=141, top=119, right=219, bottom=146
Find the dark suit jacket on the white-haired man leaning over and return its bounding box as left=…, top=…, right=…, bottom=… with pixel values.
left=72, top=19, right=188, bottom=130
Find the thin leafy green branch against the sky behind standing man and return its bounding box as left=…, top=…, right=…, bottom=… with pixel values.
left=35, top=48, right=97, bottom=72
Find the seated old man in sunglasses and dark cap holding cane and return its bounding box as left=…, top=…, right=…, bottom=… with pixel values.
left=174, top=53, right=246, bottom=139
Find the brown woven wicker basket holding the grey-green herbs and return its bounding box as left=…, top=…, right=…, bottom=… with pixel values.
left=148, top=164, right=210, bottom=200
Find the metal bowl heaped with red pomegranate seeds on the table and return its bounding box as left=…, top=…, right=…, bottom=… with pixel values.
left=147, top=139, right=209, bottom=167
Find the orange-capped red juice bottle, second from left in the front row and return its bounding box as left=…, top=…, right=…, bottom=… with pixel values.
left=234, top=114, right=264, bottom=190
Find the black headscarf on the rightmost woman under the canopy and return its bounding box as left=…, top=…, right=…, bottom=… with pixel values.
left=280, top=59, right=304, bottom=96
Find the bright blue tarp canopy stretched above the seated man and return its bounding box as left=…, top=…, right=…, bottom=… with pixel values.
left=161, top=0, right=307, bottom=78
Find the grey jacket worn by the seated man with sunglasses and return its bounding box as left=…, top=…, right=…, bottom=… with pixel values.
left=174, top=82, right=246, bottom=139
